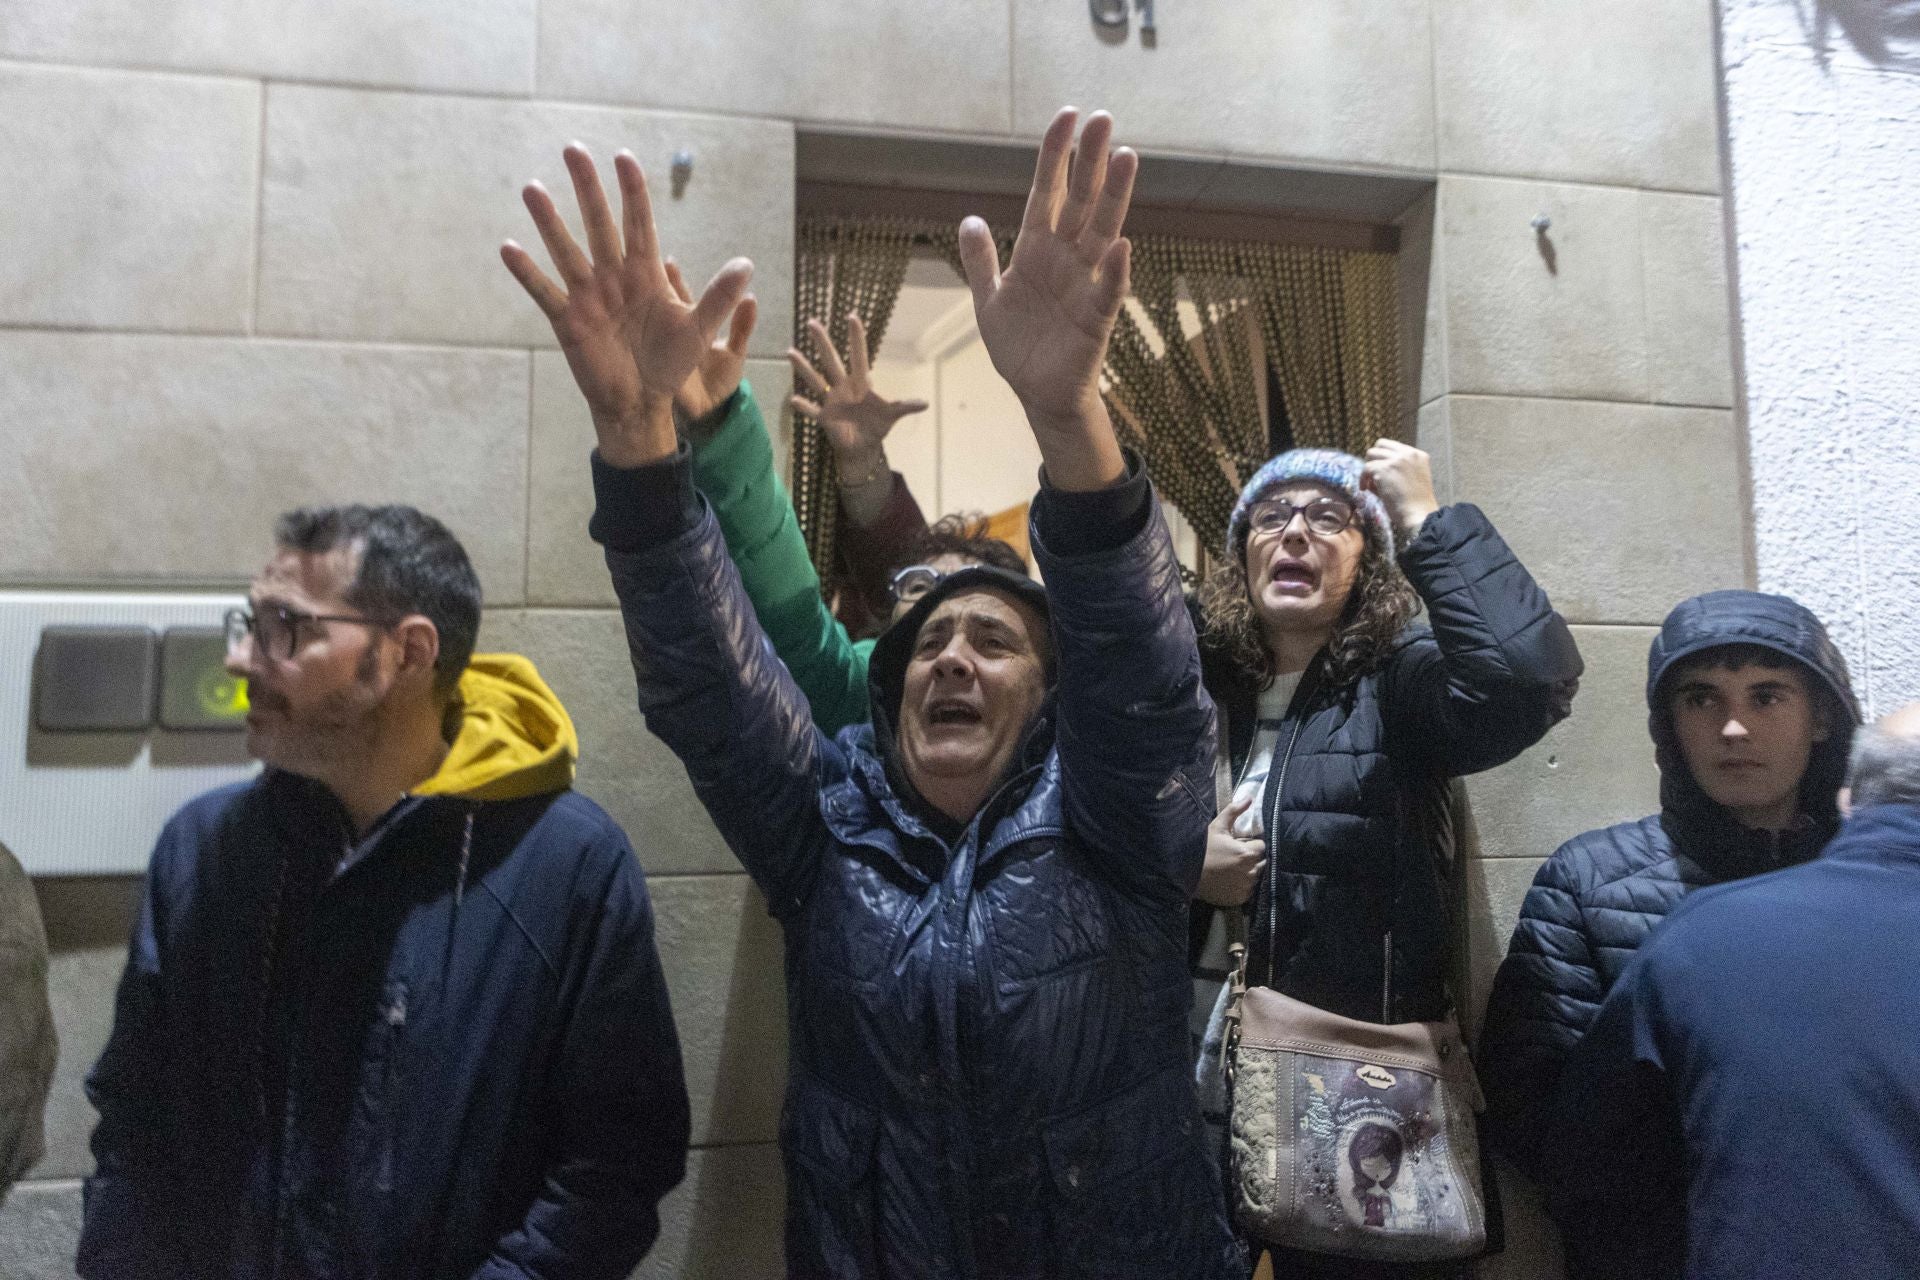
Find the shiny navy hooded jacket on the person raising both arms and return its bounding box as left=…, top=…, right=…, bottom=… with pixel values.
left=595, top=468, right=1246, bottom=1280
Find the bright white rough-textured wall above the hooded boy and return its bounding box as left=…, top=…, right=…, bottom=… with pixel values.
left=1720, top=0, right=1920, bottom=712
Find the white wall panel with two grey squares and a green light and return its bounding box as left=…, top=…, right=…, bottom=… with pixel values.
left=0, top=591, right=255, bottom=875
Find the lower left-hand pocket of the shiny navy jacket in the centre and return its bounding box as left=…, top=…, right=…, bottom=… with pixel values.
left=780, top=1069, right=879, bottom=1280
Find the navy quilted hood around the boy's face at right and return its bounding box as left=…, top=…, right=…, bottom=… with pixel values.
left=1647, top=591, right=1860, bottom=875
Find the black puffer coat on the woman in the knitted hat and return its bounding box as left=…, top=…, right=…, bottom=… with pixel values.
left=1210, top=503, right=1582, bottom=1023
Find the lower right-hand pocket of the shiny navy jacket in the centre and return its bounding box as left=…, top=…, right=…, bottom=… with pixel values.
left=1043, top=1067, right=1244, bottom=1280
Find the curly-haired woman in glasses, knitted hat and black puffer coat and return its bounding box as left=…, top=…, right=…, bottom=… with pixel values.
left=1194, top=439, right=1582, bottom=1280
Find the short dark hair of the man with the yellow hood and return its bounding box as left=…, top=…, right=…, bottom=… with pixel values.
left=273, top=505, right=480, bottom=693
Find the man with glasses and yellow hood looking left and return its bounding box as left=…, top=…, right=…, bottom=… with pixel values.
left=79, top=507, right=689, bottom=1280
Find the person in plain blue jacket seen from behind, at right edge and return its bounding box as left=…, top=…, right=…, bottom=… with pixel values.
left=1546, top=706, right=1920, bottom=1280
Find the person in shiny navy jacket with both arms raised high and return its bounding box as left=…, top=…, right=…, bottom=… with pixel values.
left=505, top=109, right=1246, bottom=1280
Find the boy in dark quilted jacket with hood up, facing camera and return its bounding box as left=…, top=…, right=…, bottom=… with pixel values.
left=1478, top=591, right=1860, bottom=1276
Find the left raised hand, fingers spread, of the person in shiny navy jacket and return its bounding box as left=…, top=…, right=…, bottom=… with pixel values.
left=499, top=142, right=753, bottom=466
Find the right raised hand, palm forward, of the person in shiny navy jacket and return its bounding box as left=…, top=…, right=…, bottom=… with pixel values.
left=960, top=107, right=1139, bottom=489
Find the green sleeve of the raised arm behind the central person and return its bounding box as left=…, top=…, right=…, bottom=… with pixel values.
left=689, top=382, right=874, bottom=735
